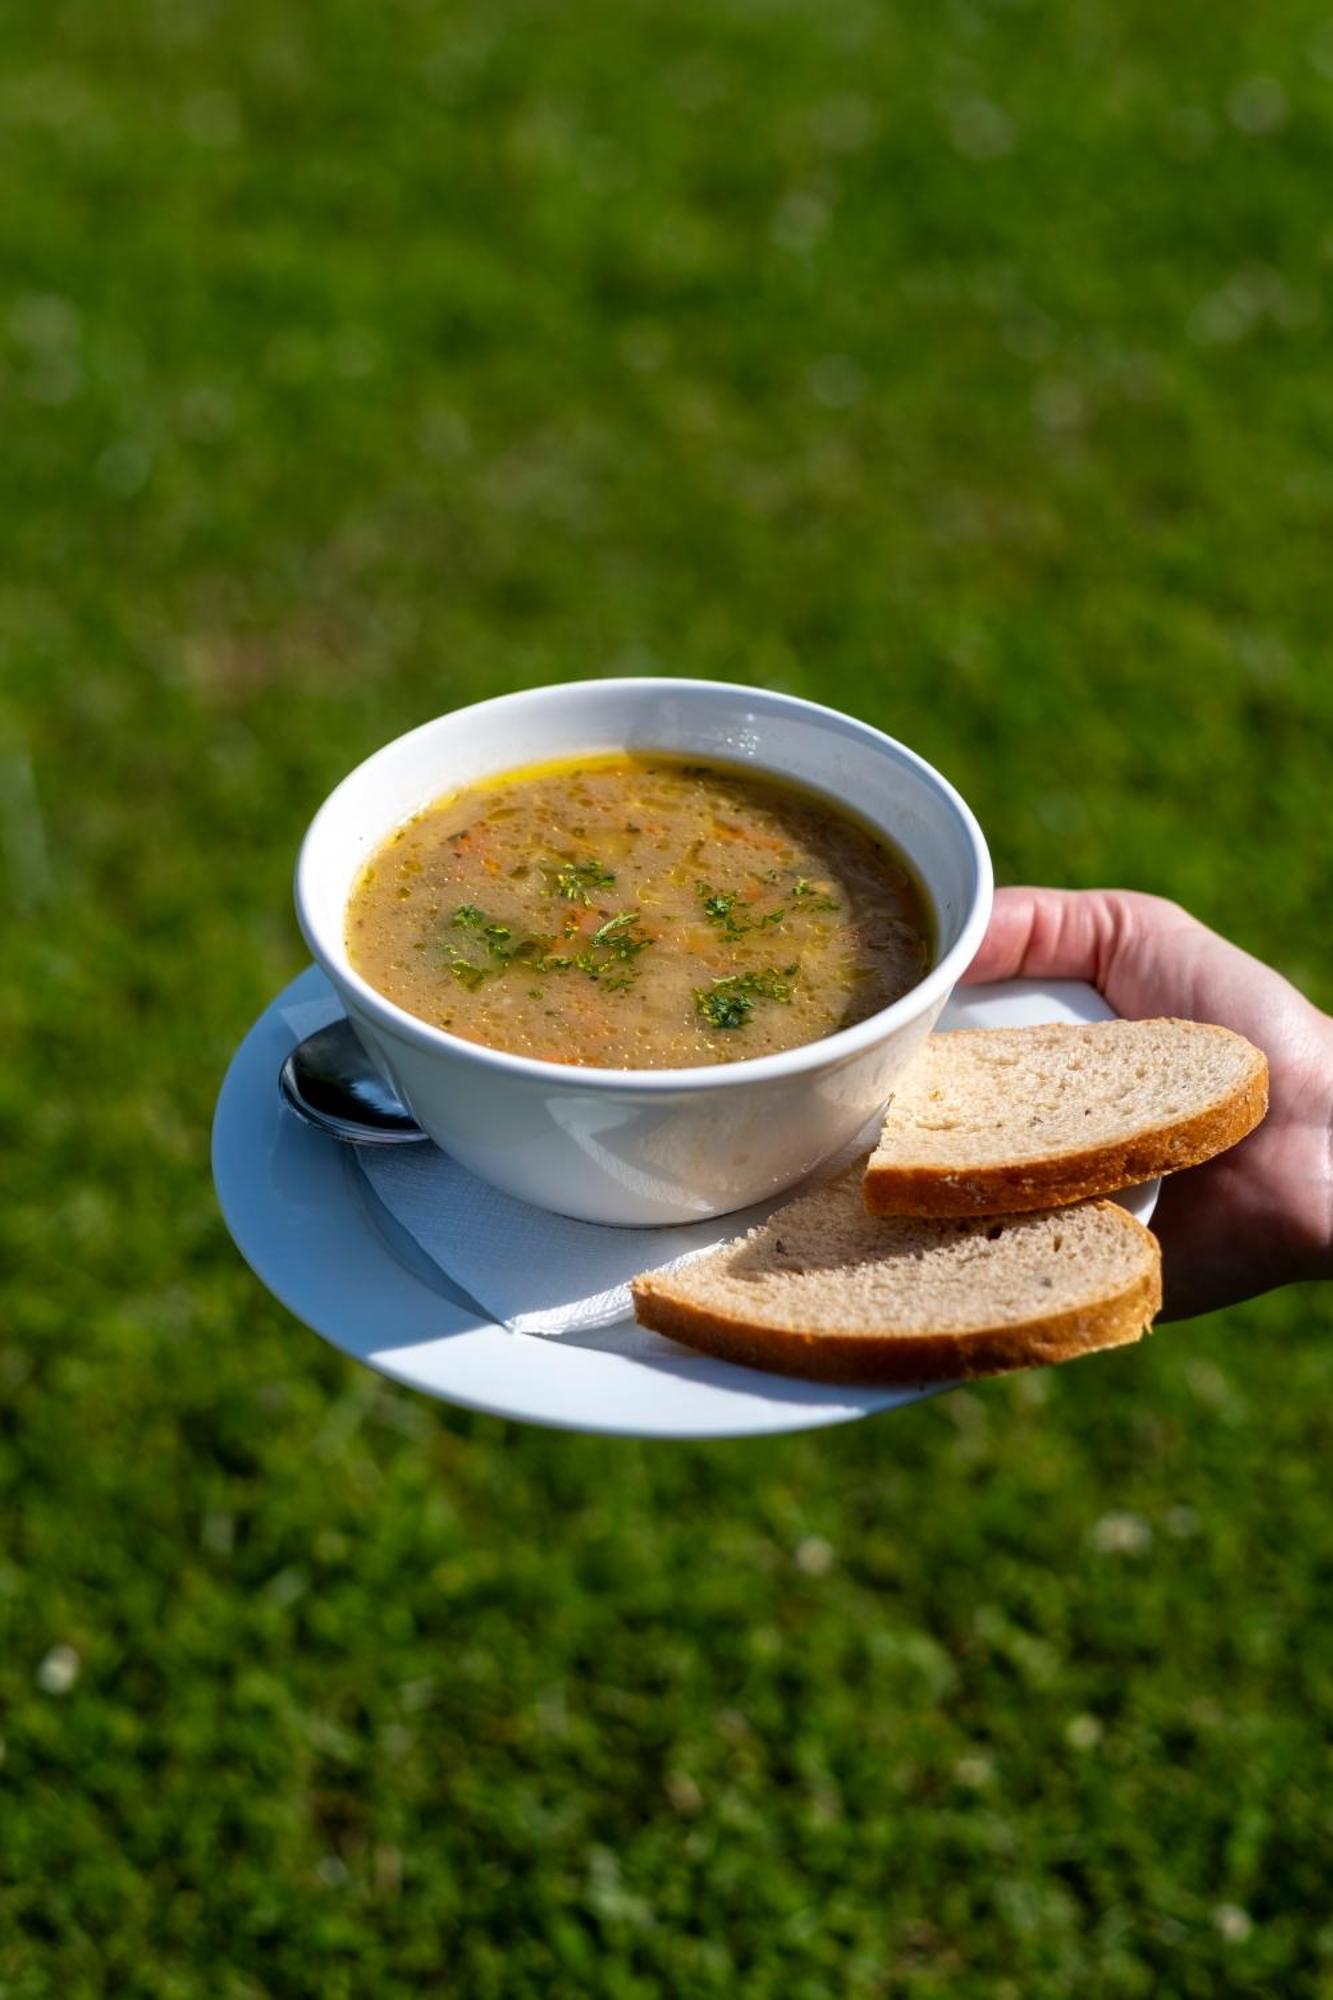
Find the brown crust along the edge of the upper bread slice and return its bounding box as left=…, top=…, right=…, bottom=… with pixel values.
left=865, top=1050, right=1269, bottom=1218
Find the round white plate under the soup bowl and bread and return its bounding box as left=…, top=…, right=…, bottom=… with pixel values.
left=212, top=966, right=1159, bottom=1438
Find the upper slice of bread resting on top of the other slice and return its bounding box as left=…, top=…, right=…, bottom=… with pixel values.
left=865, top=1020, right=1269, bottom=1216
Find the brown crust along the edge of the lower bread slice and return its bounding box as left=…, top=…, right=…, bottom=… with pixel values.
left=630, top=1218, right=1161, bottom=1388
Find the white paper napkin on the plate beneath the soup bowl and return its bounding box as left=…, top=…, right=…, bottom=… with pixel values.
left=282, top=996, right=872, bottom=1336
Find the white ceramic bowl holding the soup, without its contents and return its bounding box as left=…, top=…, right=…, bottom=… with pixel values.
left=296, top=680, right=991, bottom=1226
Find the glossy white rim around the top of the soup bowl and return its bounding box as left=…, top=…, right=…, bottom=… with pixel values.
left=294, top=674, right=995, bottom=1096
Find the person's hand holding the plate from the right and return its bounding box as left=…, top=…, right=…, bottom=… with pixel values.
left=965, top=888, right=1333, bottom=1320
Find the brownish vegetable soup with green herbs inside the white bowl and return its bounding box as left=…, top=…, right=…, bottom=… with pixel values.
left=346, top=754, right=931, bottom=1070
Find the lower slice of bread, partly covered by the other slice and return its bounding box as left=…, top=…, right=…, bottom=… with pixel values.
left=632, top=1164, right=1161, bottom=1384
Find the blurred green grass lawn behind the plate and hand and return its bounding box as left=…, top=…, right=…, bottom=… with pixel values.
left=0, top=0, right=1333, bottom=2000
